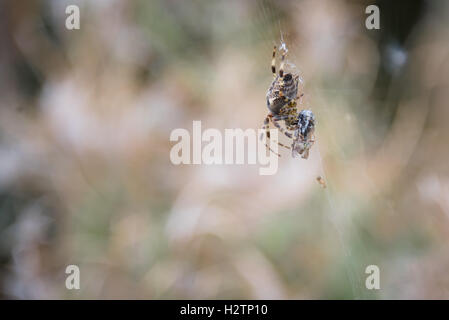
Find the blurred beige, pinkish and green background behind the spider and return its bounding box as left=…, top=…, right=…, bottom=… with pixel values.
left=0, top=0, right=449, bottom=299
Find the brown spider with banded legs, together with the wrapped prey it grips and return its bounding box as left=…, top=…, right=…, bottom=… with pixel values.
left=260, top=44, right=315, bottom=159
